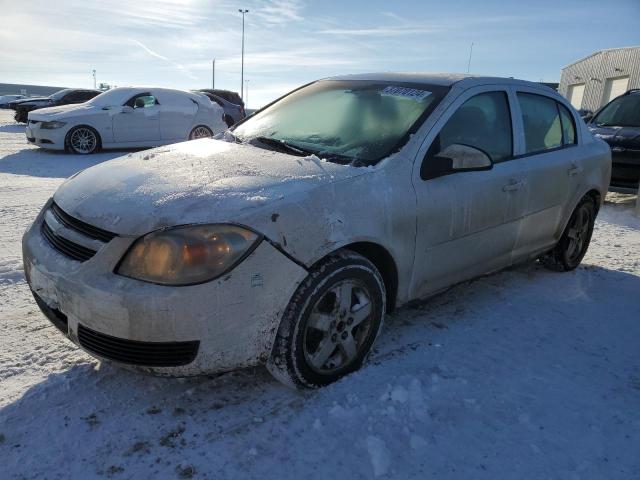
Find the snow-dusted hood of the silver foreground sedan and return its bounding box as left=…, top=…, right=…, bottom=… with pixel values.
left=54, top=139, right=368, bottom=236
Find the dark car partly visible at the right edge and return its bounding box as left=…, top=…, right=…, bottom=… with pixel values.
left=588, top=89, right=640, bottom=193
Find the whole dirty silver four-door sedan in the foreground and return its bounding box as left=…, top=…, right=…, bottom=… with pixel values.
left=23, top=74, right=611, bottom=387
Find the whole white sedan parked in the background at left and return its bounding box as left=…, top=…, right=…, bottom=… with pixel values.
left=26, top=87, right=227, bottom=154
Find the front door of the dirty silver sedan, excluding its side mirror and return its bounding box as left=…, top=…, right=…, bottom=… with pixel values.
left=411, top=85, right=528, bottom=298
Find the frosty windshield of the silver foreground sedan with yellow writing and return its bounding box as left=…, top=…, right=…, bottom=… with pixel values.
left=233, top=80, right=448, bottom=165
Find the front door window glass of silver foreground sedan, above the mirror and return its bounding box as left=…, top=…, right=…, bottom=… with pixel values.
left=425, top=92, right=513, bottom=162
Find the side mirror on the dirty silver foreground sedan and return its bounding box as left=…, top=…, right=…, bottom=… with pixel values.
left=420, top=143, right=493, bottom=180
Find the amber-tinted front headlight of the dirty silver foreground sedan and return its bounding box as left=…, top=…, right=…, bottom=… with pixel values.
left=116, top=225, right=262, bottom=286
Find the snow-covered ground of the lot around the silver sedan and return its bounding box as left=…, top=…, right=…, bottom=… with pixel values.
left=0, top=111, right=640, bottom=480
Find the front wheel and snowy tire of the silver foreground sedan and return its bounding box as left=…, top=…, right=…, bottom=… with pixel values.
left=267, top=250, right=386, bottom=388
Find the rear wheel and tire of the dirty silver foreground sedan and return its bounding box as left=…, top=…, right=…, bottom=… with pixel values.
left=540, top=196, right=597, bottom=272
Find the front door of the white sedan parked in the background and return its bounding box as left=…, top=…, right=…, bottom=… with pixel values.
left=112, top=92, right=160, bottom=143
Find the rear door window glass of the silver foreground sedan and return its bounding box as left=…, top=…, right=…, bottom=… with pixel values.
left=518, top=92, right=562, bottom=153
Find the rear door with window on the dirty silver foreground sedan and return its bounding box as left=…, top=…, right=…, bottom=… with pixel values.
left=514, top=87, right=583, bottom=256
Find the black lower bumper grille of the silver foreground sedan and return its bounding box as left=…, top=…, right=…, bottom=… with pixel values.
left=78, top=325, right=200, bottom=367
